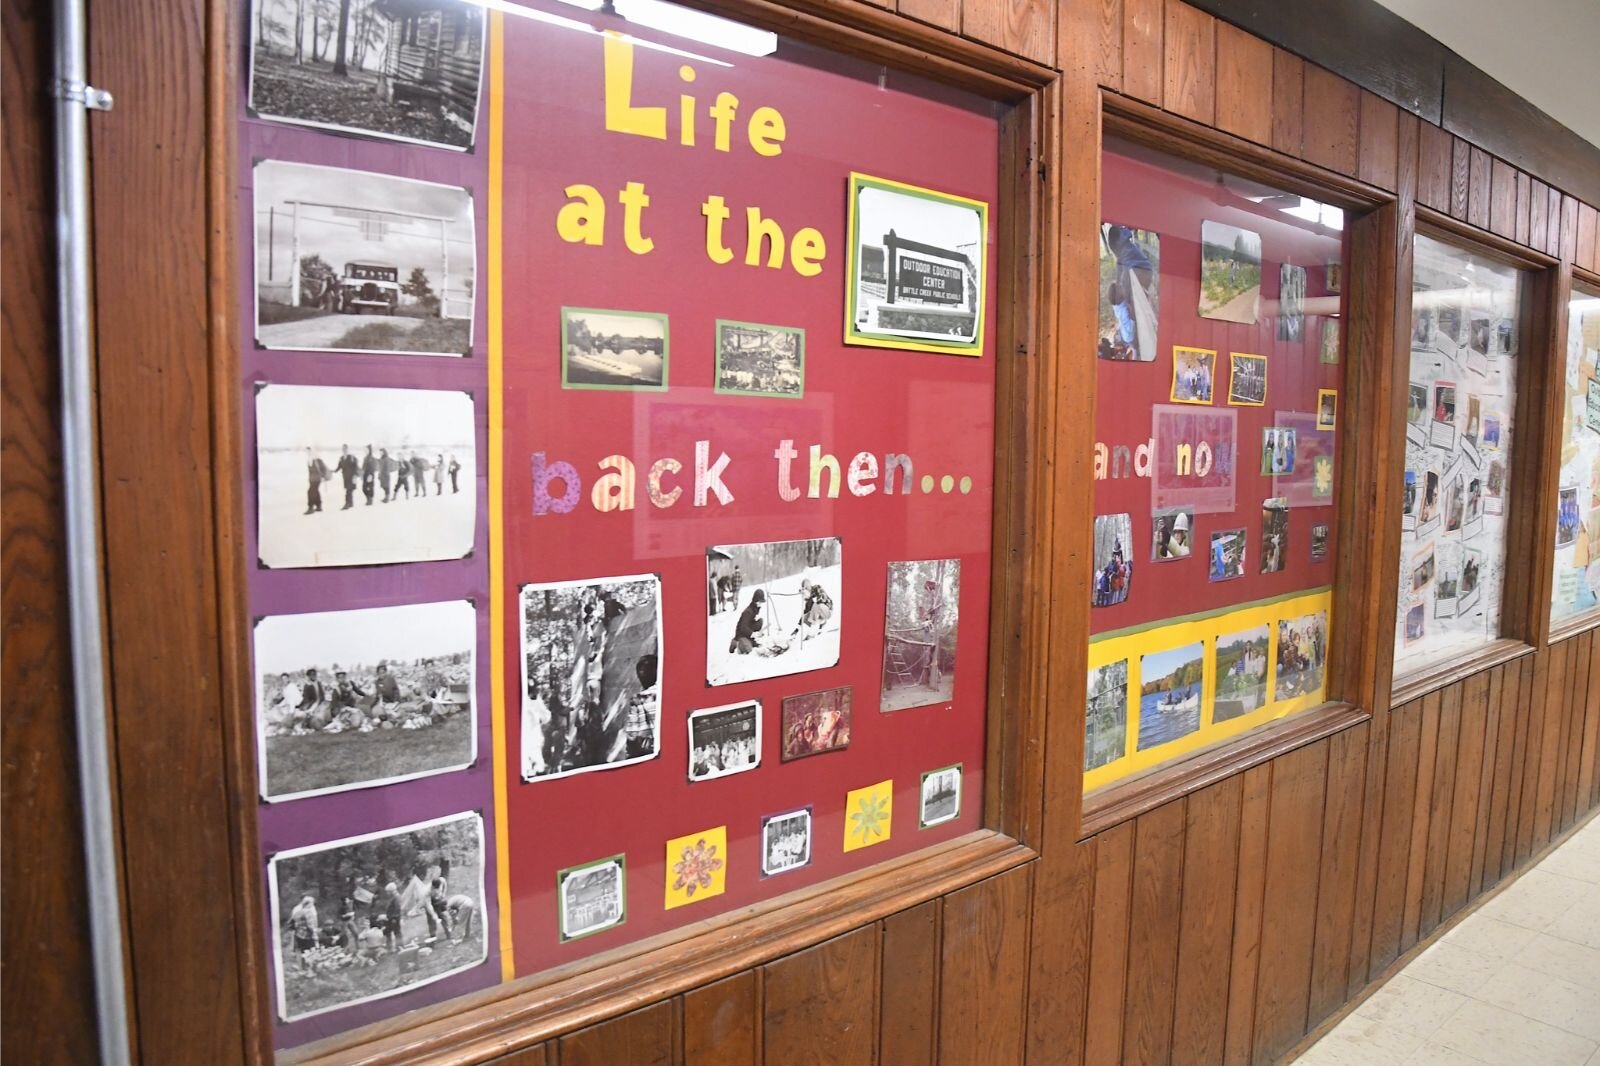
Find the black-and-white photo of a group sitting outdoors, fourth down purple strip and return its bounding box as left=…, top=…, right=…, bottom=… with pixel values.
left=254, top=600, right=478, bottom=802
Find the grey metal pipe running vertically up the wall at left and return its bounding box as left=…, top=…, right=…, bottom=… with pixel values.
left=51, top=0, right=130, bottom=1066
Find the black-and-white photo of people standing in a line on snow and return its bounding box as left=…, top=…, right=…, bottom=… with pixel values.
left=256, top=384, right=478, bottom=568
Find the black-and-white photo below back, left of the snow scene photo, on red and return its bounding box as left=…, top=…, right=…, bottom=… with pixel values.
left=517, top=573, right=661, bottom=781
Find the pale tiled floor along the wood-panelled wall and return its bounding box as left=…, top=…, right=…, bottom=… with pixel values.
left=1294, top=818, right=1600, bottom=1066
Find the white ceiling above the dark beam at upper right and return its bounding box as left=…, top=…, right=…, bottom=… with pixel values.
left=1378, top=0, right=1600, bottom=146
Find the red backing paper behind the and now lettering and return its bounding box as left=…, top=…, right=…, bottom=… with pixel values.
left=1091, top=141, right=1346, bottom=634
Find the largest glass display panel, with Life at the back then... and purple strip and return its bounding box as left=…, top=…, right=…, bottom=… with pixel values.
left=237, top=0, right=1000, bottom=1058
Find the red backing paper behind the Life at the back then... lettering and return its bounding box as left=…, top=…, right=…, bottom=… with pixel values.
left=490, top=5, right=1000, bottom=976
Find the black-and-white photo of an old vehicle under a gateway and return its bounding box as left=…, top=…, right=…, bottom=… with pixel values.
left=254, top=158, right=477, bottom=355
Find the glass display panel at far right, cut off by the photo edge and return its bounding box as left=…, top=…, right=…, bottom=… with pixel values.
left=1550, top=285, right=1600, bottom=626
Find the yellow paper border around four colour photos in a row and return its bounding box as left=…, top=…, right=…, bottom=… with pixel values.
left=1083, top=589, right=1333, bottom=792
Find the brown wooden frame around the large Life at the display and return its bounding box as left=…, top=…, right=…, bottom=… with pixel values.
left=208, top=0, right=1056, bottom=1064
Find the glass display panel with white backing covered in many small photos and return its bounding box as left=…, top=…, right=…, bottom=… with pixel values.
left=1395, top=234, right=1526, bottom=679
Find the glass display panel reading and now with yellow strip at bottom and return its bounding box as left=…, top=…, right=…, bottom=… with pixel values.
left=1083, top=139, right=1346, bottom=789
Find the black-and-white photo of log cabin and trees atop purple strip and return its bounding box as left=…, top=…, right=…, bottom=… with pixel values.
left=250, top=0, right=485, bottom=150
